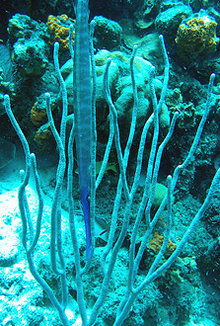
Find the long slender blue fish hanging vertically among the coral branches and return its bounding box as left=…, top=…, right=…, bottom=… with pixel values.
left=73, top=0, right=92, bottom=260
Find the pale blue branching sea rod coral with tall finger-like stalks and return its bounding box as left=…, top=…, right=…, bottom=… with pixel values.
left=4, top=0, right=220, bottom=326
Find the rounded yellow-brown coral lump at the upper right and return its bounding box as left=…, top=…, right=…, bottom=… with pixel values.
left=175, top=10, right=218, bottom=60
